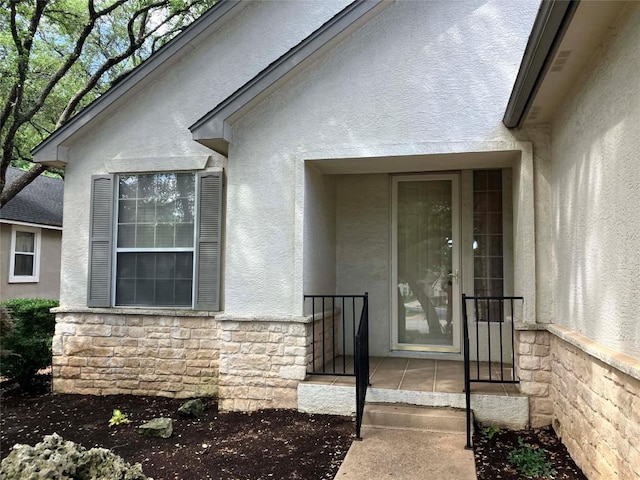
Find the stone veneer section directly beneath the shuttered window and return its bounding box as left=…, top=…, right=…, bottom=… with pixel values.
left=52, top=309, right=220, bottom=398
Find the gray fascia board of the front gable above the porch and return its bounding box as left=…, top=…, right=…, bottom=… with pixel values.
left=189, top=0, right=391, bottom=155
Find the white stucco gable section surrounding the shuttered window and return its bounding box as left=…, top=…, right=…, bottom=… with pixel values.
left=56, top=0, right=349, bottom=311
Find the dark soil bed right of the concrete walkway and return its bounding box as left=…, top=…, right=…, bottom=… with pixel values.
left=473, top=425, right=587, bottom=480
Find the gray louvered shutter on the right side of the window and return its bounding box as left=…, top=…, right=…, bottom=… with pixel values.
left=195, top=172, right=223, bottom=311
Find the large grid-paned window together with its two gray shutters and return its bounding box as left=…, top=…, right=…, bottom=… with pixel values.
left=87, top=172, right=222, bottom=310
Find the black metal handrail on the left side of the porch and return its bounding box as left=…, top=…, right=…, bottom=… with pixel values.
left=304, top=293, right=369, bottom=440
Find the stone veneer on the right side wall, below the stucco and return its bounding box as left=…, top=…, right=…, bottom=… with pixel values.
left=550, top=325, right=640, bottom=480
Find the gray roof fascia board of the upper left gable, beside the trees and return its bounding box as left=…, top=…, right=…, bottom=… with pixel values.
left=32, top=0, right=242, bottom=165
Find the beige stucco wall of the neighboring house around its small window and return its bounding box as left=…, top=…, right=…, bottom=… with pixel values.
left=0, top=223, right=62, bottom=300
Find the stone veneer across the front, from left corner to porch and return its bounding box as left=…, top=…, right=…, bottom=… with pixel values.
left=53, top=309, right=334, bottom=411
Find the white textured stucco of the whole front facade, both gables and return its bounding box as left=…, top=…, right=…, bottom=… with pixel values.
left=56, top=0, right=538, bottom=315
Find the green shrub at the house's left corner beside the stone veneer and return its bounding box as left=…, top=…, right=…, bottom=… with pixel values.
left=0, top=298, right=58, bottom=389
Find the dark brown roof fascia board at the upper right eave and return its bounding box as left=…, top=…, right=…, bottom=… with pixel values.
left=502, top=0, right=580, bottom=128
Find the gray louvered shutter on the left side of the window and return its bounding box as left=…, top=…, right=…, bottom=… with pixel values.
left=87, top=175, right=113, bottom=307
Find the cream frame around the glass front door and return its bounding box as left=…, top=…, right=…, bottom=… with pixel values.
left=389, top=172, right=463, bottom=355
